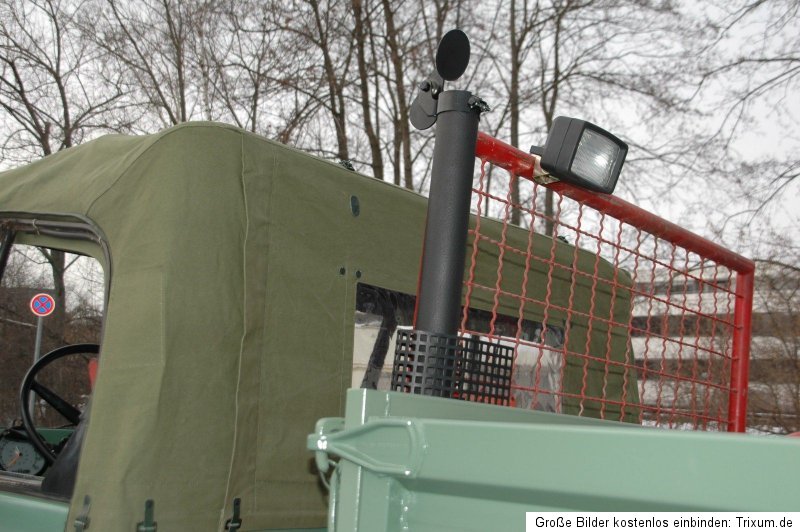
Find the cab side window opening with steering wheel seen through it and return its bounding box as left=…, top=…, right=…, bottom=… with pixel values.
left=0, top=230, right=105, bottom=488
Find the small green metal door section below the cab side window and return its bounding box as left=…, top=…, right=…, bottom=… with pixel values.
left=0, top=492, right=69, bottom=532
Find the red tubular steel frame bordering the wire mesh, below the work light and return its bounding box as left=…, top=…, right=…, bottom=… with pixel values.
left=475, top=132, right=755, bottom=432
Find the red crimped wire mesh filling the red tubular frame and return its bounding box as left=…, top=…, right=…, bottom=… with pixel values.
left=461, top=160, right=749, bottom=430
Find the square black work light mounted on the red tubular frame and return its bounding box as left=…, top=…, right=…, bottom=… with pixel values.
left=531, top=116, right=628, bottom=194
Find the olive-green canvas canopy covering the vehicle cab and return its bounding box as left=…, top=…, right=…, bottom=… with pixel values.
left=0, top=123, right=636, bottom=530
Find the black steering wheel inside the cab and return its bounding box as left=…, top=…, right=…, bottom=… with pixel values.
left=19, top=344, right=100, bottom=466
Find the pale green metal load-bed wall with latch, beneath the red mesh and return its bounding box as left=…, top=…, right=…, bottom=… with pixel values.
left=309, top=390, right=800, bottom=531
